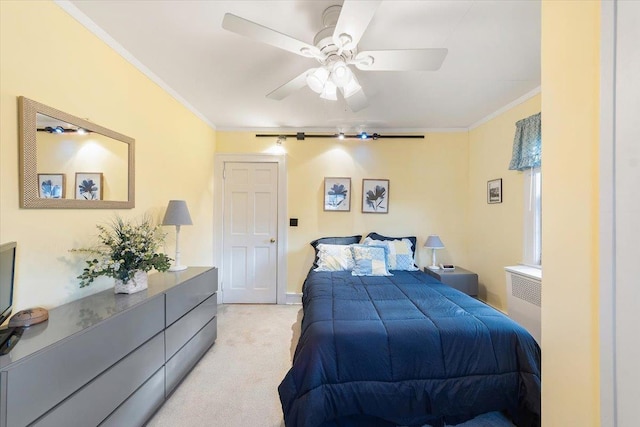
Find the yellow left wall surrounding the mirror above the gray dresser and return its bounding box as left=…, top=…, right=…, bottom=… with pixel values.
left=0, top=1, right=215, bottom=309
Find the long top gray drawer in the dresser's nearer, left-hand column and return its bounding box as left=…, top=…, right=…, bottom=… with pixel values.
left=3, top=295, right=164, bottom=427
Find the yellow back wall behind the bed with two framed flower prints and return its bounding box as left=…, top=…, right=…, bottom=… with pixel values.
left=217, top=132, right=469, bottom=292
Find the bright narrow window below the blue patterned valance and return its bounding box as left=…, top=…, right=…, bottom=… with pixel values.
left=522, top=167, right=542, bottom=266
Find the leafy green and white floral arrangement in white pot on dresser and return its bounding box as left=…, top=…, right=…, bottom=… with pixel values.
left=72, top=217, right=171, bottom=294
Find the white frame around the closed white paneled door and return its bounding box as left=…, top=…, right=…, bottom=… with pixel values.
left=213, top=154, right=287, bottom=304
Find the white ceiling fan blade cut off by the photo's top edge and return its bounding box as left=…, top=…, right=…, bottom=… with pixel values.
left=333, top=0, right=382, bottom=49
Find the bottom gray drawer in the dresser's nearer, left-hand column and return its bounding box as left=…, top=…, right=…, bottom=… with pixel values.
left=100, top=366, right=164, bottom=427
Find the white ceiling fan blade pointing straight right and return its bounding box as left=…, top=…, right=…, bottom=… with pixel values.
left=350, top=48, right=449, bottom=71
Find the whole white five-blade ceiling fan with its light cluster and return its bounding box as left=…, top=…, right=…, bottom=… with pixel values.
left=222, top=0, right=448, bottom=112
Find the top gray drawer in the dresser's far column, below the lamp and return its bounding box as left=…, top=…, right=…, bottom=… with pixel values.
left=166, top=268, right=218, bottom=326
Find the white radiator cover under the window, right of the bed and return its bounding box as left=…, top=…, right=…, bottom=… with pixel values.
left=504, top=265, right=542, bottom=344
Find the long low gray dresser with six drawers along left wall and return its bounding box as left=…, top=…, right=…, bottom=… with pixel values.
left=0, top=267, right=218, bottom=427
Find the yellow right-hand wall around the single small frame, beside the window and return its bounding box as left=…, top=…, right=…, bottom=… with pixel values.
left=468, top=95, right=540, bottom=311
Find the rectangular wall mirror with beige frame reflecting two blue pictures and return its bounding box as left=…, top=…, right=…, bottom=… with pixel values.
left=19, top=97, right=134, bottom=209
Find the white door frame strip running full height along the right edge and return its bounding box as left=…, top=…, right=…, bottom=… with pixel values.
left=598, top=0, right=640, bottom=427
